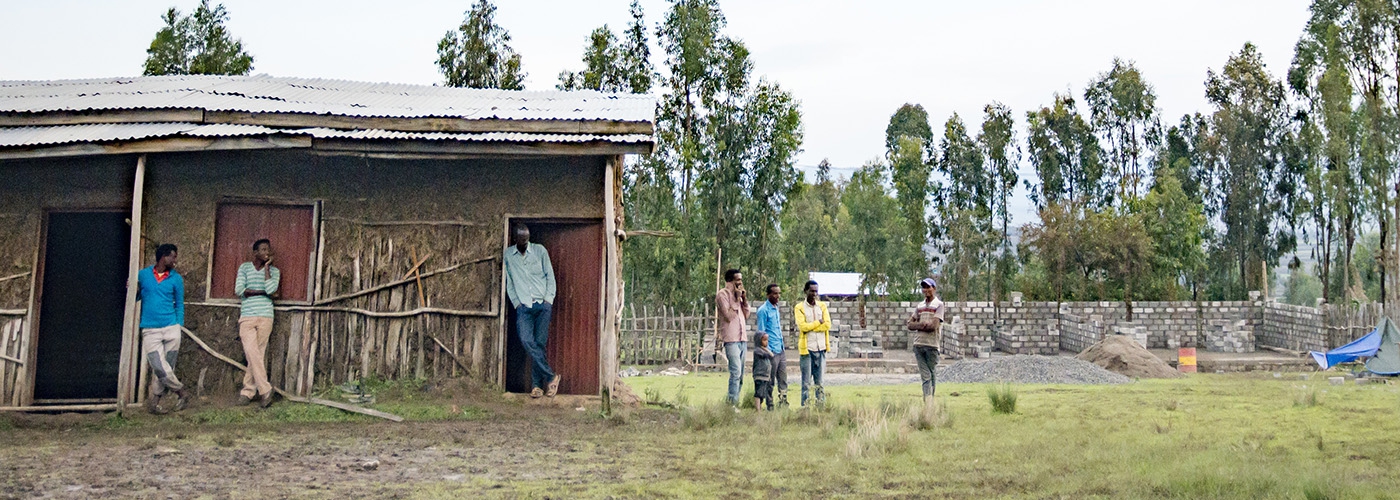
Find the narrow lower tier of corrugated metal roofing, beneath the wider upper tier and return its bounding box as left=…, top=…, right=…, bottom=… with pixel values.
left=0, top=123, right=651, bottom=147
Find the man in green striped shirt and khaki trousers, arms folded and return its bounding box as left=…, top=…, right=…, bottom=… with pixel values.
left=234, top=239, right=281, bottom=408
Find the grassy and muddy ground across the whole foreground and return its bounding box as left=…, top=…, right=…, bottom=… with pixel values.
left=0, top=374, right=1400, bottom=499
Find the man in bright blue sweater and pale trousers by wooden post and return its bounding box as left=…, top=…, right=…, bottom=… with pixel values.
left=136, top=244, right=189, bottom=415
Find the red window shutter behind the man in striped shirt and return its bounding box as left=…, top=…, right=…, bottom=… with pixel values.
left=209, top=203, right=316, bottom=301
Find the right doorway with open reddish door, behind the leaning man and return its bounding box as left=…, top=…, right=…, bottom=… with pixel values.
left=505, top=220, right=603, bottom=395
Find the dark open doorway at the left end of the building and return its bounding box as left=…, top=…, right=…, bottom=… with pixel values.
left=34, top=211, right=134, bottom=402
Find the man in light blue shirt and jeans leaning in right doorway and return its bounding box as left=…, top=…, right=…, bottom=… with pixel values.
left=504, top=224, right=559, bottom=398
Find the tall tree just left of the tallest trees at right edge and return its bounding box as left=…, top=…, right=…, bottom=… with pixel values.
left=1205, top=43, right=1295, bottom=298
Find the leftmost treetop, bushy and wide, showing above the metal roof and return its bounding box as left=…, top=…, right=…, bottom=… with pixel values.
left=143, top=0, right=253, bottom=76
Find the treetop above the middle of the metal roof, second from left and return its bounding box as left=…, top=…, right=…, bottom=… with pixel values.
left=437, top=0, right=526, bottom=90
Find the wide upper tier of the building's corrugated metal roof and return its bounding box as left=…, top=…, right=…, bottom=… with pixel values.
left=0, top=76, right=655, bottom=123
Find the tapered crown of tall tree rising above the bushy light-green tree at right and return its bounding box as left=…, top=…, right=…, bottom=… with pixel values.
left=1084, top=57, right=1161, bottom=204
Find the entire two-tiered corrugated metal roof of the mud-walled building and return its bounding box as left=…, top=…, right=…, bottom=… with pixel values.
left=0, top=76, right=657, bottom=158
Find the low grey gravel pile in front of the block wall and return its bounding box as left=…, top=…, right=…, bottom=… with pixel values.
left=938, top=356, right=1131, bottom=384
